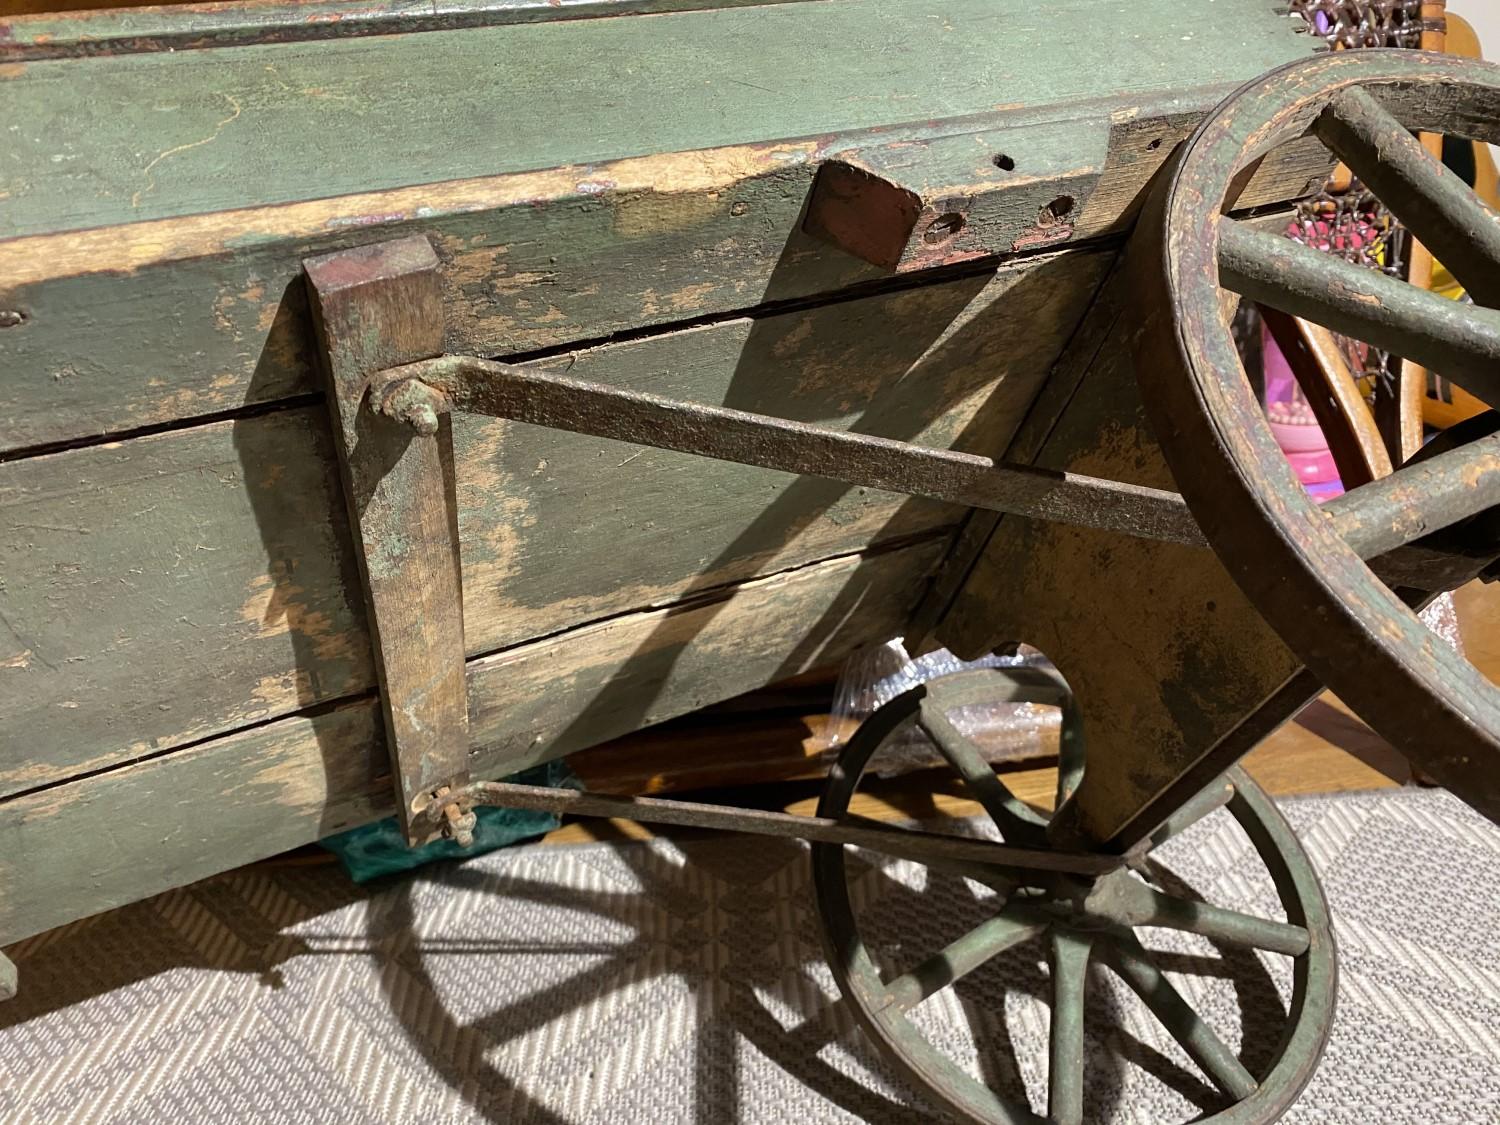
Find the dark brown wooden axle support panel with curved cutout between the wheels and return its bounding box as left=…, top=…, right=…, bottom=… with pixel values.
left=938, top=303, right=1299, bottom=840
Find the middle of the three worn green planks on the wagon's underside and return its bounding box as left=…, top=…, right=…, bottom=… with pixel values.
left=0, top=252, right=1110, bottom=794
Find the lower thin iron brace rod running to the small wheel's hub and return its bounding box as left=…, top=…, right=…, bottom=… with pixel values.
left=462, top=782, right=1124, bottom=876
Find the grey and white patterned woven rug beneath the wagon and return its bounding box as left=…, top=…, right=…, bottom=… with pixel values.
left=0, top=791, right=1500, bottom=1125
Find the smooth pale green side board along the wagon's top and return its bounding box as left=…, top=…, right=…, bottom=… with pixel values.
left=0, top=0, right=1308, bottom=234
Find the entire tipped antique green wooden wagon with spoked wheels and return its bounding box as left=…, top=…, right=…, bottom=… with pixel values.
left=0, top=0, right=1500, bottom=1122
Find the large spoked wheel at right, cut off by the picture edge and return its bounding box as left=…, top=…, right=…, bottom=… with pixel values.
left=1130, top=51, right=1500, bottom=819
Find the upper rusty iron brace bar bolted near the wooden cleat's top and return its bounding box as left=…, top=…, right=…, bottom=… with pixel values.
left=371, top=356, right=1205, bottom=546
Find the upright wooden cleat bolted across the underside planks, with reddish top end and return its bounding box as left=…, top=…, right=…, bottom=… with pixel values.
left=303, top=237, right=473, bottom=846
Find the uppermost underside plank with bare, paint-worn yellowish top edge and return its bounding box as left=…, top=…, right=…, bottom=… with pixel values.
left=0, top=116, right=1338, bottom=453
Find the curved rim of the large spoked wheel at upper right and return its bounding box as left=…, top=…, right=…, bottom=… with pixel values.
left=1130, top=51, right=1500, bottom=818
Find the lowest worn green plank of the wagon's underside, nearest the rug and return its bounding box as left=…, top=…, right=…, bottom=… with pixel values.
left=0, top=539, right=944, bottom=944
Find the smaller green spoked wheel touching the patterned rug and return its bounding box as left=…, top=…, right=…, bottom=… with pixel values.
left=812, top=668, right=1337, bottom=1125
